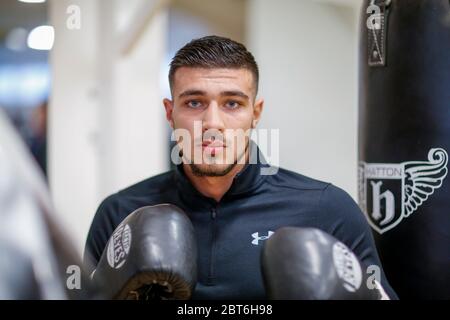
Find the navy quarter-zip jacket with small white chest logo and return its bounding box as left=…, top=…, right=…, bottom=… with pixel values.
left=84, top=149, right=397, bottom=299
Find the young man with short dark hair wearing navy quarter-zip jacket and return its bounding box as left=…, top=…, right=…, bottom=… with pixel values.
left=85, top=36, right=396, bottom=299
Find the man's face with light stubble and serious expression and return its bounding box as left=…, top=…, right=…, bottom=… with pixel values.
left=164, top=67, right=263, bottom=176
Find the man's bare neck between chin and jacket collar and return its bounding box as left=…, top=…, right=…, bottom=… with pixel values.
left=183, top=155, right=248, bottom=202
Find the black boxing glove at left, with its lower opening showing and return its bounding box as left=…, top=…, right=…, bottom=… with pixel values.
left=92, top=204, right=197, bottom=300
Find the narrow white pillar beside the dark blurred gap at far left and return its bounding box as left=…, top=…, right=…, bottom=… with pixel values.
left=48, top=0, right=100, bottom=255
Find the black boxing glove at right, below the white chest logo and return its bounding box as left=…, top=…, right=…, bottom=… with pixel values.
left=261, top=227, right=387, bottom=300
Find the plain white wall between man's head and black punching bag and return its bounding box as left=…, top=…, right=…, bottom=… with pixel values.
left=247, top=0, right=358, bottom=197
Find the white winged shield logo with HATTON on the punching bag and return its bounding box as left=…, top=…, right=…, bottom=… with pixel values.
left=358, top=148, right=448, bottom=234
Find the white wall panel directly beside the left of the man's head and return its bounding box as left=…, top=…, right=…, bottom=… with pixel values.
left=100, top=0, right=169, bottom=198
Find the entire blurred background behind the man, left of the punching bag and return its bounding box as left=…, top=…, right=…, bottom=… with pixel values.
left=0, top=0, right=360, bottom=253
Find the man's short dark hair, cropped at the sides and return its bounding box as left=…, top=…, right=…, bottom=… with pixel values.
left=169, top=36, right=259, bottom=94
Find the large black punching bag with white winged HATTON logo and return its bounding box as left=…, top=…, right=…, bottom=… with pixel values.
left=359, top=0, right=450, bottom=299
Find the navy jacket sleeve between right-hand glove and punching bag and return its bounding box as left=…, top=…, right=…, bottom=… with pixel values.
left=319, top=184, right=398, bottom=299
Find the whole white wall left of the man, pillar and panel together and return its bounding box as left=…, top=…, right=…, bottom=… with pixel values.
left=48, top=0, right=168, bottom=253
